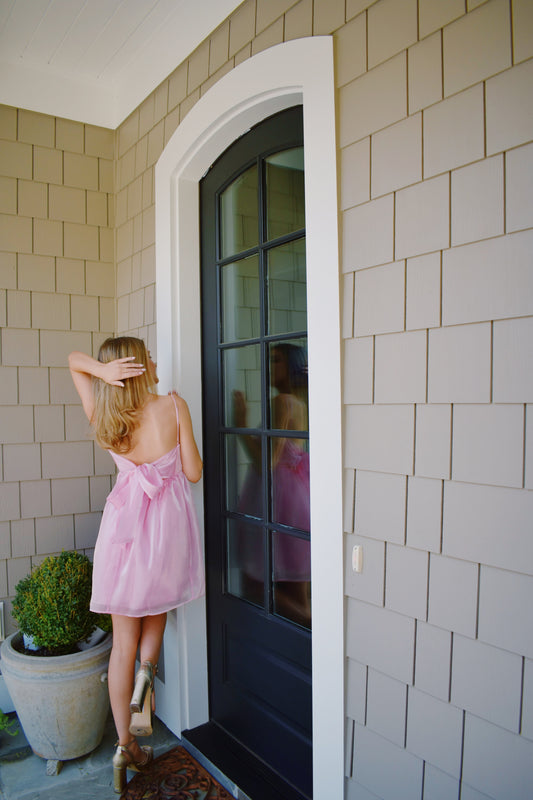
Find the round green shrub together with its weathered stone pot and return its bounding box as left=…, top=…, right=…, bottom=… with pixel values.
left=0, top=551, right=111, bottom=771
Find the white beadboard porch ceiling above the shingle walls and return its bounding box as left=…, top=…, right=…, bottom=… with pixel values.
left=0, top=0, right=242, bottom=128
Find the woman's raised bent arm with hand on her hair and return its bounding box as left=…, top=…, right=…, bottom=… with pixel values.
left=68, top=350, right=145, bottom=421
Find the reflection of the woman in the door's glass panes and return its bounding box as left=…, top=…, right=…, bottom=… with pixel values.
left=234, top=342, right=311, bottom=626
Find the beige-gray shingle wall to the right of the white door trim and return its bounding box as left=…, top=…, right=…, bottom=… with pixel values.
left=335, top=0, right=533, bottom=800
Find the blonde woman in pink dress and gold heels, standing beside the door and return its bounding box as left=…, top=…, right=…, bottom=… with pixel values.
left=69, top=336, right=204, bottom=793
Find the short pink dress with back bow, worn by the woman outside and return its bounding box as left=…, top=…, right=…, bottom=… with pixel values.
left=91, top=401, right=205, bottom=617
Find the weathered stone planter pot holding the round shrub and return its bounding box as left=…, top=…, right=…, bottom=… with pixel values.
left=0, top=633, right=112, bottom=761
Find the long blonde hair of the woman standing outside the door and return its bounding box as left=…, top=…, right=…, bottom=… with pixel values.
left=93, top=336, right=155, bottom=453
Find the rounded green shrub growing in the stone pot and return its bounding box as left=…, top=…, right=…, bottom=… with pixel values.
left=13, top=551, right=108, bottom=655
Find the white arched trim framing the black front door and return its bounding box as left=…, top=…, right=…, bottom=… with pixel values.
left=156, top=37, right=344, bottom=800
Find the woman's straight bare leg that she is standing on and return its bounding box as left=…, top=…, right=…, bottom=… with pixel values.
left=108, top=614, right=142, bottom=760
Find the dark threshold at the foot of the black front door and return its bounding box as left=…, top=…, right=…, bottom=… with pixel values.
left=181, top=722, right=310, bottom=800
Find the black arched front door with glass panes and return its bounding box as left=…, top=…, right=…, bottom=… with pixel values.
left=197, top=107, right=312, bottom=797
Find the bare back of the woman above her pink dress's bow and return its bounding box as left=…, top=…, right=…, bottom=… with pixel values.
left=116, top=395, right=179, bottom=464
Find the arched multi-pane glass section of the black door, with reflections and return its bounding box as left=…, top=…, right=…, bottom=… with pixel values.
left=219, top=147, right=311, bottom=628
